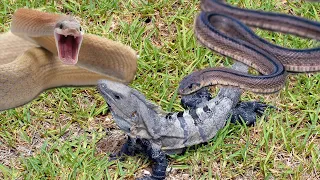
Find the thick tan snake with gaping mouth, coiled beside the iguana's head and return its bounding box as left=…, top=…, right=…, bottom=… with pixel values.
left=0, top=9, right=137, bottom=110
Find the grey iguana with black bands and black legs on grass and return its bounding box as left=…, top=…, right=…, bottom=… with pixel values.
left=98, top=63, right=267, bottom=179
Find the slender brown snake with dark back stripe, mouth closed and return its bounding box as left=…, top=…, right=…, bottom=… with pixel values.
left=179, top=0, right=320, bottom=95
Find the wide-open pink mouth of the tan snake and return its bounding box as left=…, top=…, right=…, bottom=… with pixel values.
left=54, top=32, right=83, bottom=65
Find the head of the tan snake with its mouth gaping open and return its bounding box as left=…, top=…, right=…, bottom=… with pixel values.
left=54, top=17, right=84, bottom=65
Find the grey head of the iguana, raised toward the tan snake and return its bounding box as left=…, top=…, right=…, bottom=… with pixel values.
left=98, top=80, right=162, bottom=138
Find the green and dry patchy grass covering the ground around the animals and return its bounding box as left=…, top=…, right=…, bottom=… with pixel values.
left=0, top=0, right=320, bottom=179
